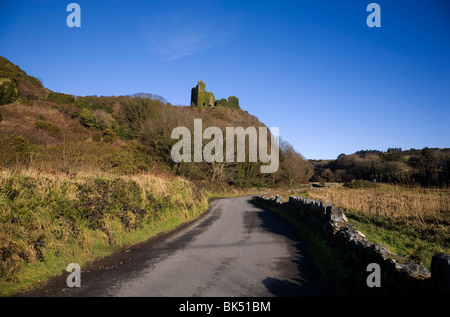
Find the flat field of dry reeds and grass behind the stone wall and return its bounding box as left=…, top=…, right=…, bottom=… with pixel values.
left=300, top=184, right=450, bottom=268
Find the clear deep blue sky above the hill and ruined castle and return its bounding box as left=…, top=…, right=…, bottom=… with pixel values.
left=0, top=0, right=450, bottom=159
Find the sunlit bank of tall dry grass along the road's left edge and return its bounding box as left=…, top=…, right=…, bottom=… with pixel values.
left=0, top=171, right=256, bottom=296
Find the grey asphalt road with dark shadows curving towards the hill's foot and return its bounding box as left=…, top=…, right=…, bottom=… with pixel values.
left=26, top=197, right=330, bottom=297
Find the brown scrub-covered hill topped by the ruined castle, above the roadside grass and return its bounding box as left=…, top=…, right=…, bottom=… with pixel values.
left=0, top=57, right=310, bottom=186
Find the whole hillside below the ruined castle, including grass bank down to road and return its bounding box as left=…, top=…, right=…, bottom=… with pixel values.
left=0, top=57, right=312, bottom=296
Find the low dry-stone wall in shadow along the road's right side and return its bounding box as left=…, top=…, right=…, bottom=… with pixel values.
left=255, top=195, right=450, bottom=295
